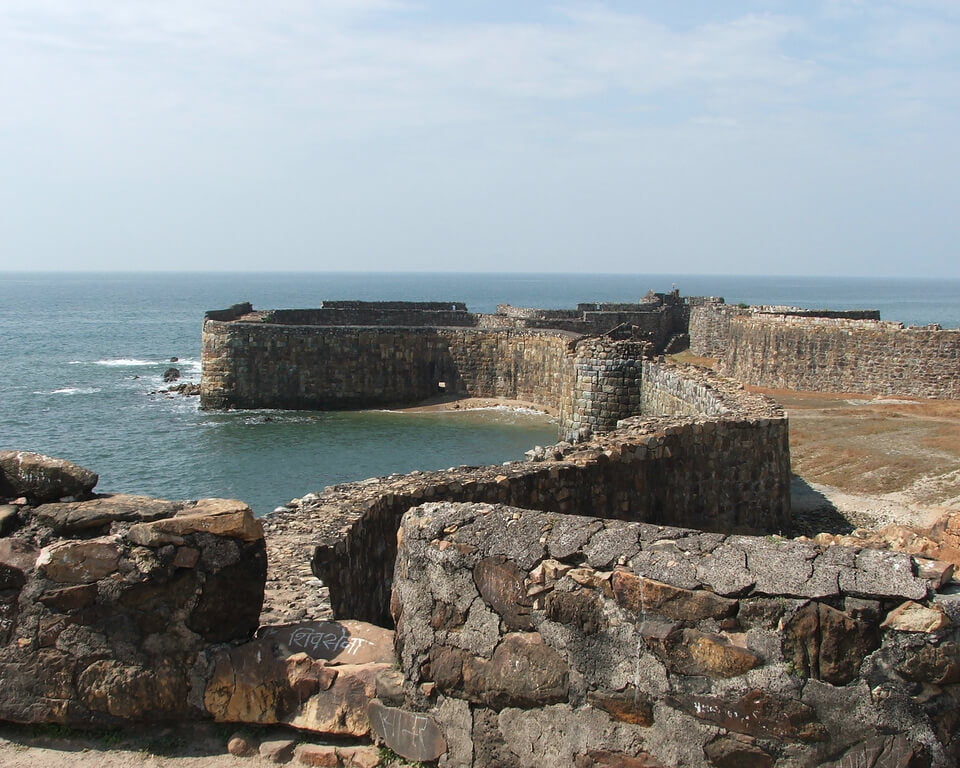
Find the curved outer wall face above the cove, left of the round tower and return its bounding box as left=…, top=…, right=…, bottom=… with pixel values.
left=200, top=319, right=575, bottom=412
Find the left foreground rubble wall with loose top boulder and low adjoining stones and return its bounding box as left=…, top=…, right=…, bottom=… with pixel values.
left=0, top=451, right=408, bottom=752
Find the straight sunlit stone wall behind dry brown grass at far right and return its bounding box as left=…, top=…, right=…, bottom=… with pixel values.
left=720, top=315, right=960, bottom=399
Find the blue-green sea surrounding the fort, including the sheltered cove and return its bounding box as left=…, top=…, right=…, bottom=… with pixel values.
left=0, top=273, right=960, bottom=513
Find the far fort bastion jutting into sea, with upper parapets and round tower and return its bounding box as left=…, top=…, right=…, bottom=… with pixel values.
left=200, top=293, right=688, bottom=439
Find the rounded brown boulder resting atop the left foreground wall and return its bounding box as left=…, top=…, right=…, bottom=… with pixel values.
left=0, top=451, right=99, bottom=502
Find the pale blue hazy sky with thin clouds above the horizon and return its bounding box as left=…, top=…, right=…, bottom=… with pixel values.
left=0, top=0, right=960, bottom=277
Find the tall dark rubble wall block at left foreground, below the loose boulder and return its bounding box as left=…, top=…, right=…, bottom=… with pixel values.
left=0, top=496, right=266, bottom=726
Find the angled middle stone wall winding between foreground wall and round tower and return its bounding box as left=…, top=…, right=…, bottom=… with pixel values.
left=290, top=363, right=790, bottom=622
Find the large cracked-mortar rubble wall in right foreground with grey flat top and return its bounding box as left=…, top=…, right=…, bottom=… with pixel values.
left=393, top=503, right=960, bottom=768
